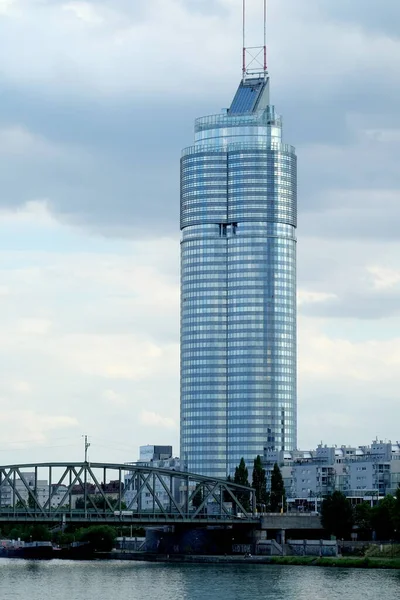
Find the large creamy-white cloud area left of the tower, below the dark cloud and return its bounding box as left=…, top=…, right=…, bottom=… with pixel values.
left=0, top=217, right=179, bottom=462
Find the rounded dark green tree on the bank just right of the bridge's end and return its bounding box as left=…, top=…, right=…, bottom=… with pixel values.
left=321, top=491, right=354, bottom=539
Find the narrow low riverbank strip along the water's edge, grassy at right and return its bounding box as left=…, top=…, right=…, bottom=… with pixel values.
left=108, top=552, right=400, bottom=569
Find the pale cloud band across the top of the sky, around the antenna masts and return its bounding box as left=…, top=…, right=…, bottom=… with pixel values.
left=0, top=0, right=400, bottom=97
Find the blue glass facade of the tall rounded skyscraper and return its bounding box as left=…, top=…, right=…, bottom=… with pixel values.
left=181, top=79, right=297, bottom=477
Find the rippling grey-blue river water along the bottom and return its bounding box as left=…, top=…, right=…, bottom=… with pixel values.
left=0, top=559, right=400, bottom=600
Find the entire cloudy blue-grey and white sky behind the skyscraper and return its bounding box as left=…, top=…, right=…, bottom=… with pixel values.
left=0, top=0, right=400, bottom=464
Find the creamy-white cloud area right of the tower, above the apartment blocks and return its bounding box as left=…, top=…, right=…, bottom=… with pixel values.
left=298, top=317, right=400, bottom=448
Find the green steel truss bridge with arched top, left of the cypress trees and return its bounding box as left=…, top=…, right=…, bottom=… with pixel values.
left=0, top=462, right=259, bottom=525
